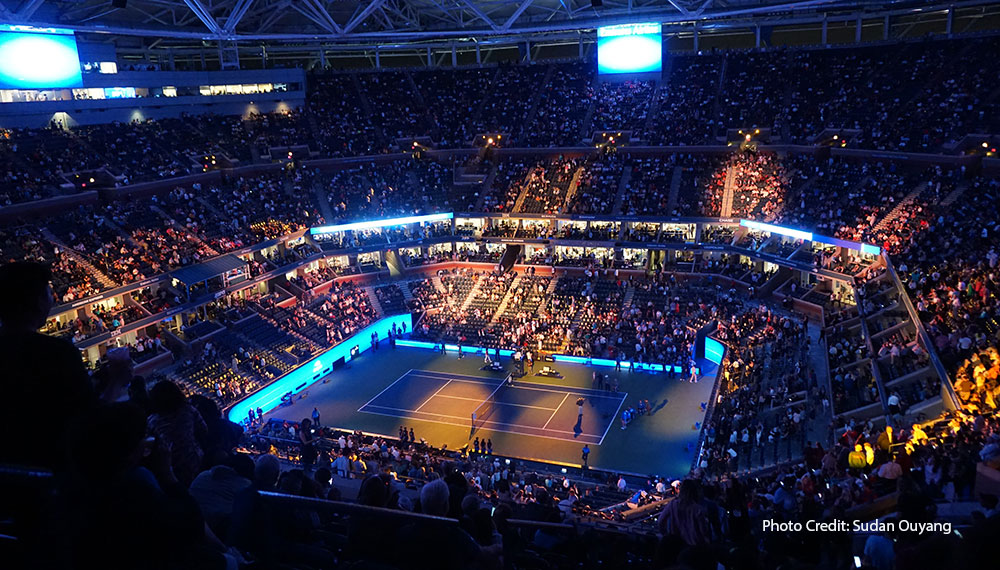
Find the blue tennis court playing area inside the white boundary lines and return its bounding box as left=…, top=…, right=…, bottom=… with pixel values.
left=358, top=370, right=627, bottom=445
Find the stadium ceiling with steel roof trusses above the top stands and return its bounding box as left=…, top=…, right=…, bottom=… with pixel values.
left=0, top=0, right=989, bottom=43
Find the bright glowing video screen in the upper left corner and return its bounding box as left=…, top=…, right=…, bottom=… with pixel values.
left=0, top=25, right=83, bottom=89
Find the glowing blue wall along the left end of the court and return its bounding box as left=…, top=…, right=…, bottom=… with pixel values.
left=228, top=313, right=413, bottom=423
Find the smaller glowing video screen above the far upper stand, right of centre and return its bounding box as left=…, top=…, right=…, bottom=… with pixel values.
left=597, top=24, right=663, bottom=73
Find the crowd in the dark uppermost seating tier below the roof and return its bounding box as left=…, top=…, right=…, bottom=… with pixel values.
left=0, top=38, right=1000, bottom=210
